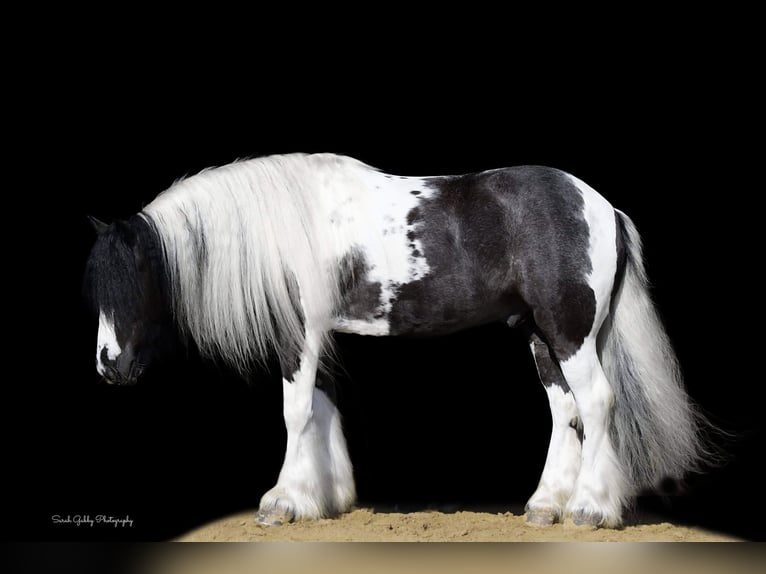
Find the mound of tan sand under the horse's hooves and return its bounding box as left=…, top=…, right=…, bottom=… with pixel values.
left=179, top=508, right=736, bottom=542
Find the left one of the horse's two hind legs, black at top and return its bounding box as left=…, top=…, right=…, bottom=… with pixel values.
left=526, top=333, right=582, bottom=525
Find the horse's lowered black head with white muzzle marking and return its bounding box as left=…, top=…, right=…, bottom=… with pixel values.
left=85, top=216, right=170, bottom=385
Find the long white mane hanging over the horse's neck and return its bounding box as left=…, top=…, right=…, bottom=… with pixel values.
left=142, top=154, right=364, bottom=371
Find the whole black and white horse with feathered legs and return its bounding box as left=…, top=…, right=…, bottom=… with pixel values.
left=86, top=154, right=702, bottom=527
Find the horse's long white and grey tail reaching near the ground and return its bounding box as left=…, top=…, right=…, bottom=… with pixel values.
left=599, top=211, right=706, bottom=492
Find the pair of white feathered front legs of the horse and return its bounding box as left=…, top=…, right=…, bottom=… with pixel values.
left=256, top=332, right=356, bottom=526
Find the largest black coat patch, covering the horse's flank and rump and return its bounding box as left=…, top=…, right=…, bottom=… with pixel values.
left=389, top=166, right=596, bottom=361
